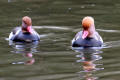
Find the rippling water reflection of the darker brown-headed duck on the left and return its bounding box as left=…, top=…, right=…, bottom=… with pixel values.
left=9, top=42, right=38, bottom=65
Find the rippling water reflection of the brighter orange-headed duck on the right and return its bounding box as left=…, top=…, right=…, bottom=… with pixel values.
left=74, top=48, right=104, bottom=80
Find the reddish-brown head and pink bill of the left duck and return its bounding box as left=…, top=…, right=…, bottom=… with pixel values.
left=22, top=16, right=32, bottom=33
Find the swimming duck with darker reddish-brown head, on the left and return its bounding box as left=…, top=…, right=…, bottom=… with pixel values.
left=9, top=16, right=40, bottom=42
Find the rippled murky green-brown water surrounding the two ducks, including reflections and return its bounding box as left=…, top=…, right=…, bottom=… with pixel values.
left=0, top=0, right=120, bottom=80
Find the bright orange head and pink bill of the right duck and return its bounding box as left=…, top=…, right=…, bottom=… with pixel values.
left=82, top=16, right=94, bottom=39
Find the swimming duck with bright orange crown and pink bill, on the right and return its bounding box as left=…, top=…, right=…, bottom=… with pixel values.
left=72, top=16, right=103, bottom=47
